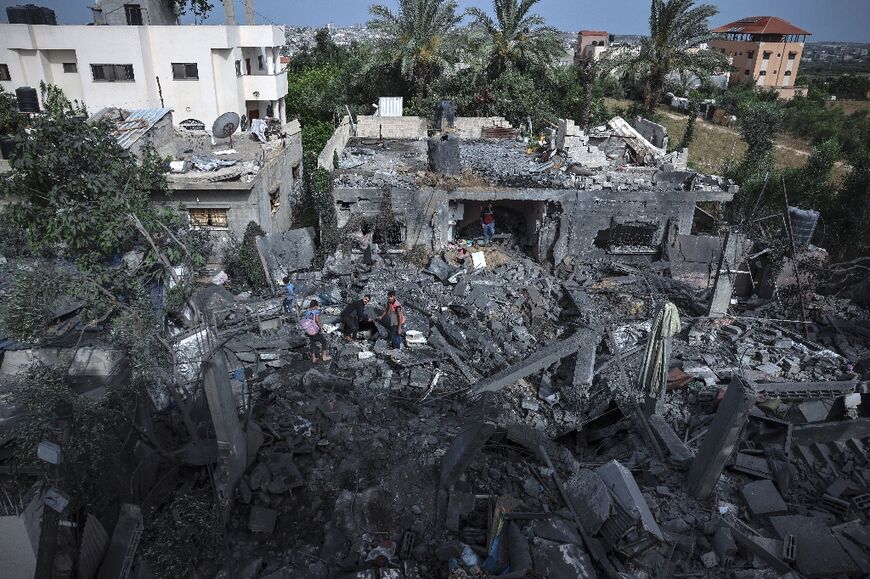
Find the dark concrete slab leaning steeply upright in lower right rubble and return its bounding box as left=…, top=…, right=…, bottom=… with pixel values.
left=688, top=376, right=752, bottom=499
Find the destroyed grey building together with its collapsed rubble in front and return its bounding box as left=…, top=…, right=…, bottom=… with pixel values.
left=0, top=102, right=870, bottom=579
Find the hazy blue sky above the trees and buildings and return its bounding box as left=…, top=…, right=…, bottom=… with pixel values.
left=0, top=0, right=870, bottom=43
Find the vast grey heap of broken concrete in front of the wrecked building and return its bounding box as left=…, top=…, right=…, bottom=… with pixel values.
left=160, top=239, right=870, bottom=578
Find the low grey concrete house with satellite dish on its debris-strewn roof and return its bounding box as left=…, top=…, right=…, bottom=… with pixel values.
left=93, top=108, right=302, bottom=258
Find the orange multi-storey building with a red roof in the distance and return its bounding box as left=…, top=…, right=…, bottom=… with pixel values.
left=710, top=16, right=811, bottom=99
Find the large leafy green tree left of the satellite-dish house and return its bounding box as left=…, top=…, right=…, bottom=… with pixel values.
left=0, top=114, right=166, bottom=267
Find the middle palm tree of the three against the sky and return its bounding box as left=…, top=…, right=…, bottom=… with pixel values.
left=466, top=0, right=562, bottom=78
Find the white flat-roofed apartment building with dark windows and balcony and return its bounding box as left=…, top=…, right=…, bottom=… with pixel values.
left=0, top=17, right=287, bottom=130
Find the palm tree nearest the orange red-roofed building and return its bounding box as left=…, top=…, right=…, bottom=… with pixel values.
left=606, top=0, right=728, bottom=114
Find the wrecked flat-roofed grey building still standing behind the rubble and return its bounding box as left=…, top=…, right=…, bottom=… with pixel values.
left=321, top=111, right=734, bottom=264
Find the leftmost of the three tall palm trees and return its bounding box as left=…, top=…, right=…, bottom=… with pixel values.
left=368, top=0, right=461, bottom=98
